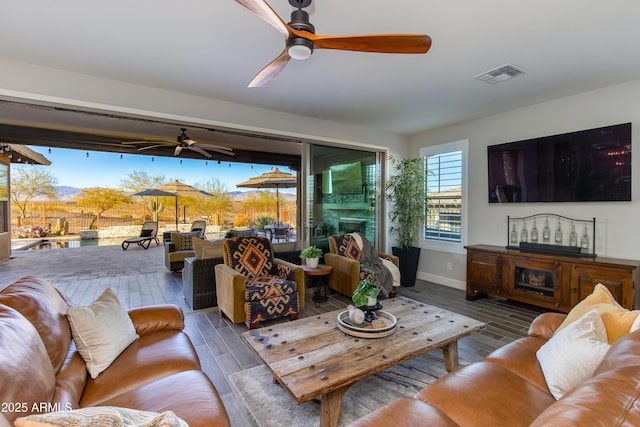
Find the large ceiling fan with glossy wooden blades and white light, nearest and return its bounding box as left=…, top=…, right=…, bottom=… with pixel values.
left=236, top=0, right=431, bottom=87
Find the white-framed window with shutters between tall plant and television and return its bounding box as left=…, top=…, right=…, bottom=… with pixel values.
left=420, top=140, right=468, bottom=252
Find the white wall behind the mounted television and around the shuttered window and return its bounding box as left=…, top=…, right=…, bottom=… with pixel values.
left=410, top=80, right=640, bottom=288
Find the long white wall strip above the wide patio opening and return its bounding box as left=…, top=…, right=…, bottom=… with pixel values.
left=0, top=58, right=406, bottom=152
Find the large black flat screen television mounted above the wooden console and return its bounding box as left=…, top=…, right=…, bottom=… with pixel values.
left=487, top=123, right=631, bottom=203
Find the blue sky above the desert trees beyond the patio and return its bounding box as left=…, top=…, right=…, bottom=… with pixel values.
left=24, top=146, right=295, bottom=193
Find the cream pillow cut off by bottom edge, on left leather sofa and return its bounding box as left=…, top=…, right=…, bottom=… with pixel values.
left=15, top=406, right=189, bottom=427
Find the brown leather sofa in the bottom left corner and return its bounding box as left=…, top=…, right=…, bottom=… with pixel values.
left=0, top=277, right=231, bottom=427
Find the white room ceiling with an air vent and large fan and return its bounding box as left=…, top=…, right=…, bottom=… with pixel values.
left=0, top=0, right=640, bottom=142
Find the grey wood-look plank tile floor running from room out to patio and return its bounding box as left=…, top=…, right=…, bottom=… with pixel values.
left=0, top=245, right=541, bottom=427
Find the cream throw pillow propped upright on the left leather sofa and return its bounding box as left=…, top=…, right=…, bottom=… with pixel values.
left=67, top=288, right=138, bottom=378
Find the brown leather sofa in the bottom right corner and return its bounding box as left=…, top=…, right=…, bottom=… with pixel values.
left=350, top=313, right=640, bottom=427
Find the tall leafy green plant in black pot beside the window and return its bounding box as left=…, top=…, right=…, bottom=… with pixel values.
left=386, top=157, right=427, bottom=286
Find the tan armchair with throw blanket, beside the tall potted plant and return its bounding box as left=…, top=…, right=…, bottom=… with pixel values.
left=324, top=233, right=400, bottom=297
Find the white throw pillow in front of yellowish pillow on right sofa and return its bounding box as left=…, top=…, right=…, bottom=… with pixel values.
left=536, top=309, right=610, bottom=400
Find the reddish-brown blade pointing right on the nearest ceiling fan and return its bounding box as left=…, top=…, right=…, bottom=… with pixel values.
left=291, top=29, right=431, bottom=53
